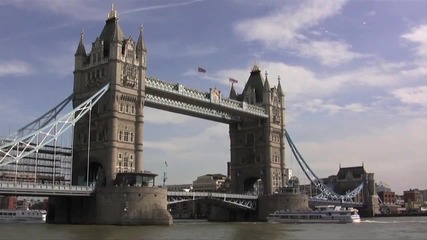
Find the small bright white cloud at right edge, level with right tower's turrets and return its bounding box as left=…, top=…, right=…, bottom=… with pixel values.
left=392, top=86, right=427, bottom=107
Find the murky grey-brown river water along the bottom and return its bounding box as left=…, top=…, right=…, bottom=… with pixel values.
left=0, top=217, right=427, bottom=240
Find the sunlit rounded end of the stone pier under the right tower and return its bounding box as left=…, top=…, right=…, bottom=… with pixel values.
left=258, top=193, right=309, bottom=221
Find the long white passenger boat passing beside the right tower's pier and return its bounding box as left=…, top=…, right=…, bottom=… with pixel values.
left=267, top=205, right=360, bottom=223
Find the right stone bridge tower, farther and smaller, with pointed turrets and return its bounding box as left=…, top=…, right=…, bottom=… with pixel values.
left=229, top=65, right=285, bottom=194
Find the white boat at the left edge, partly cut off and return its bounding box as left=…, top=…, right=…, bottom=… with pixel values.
left=0, top=208, right=47, bottom=223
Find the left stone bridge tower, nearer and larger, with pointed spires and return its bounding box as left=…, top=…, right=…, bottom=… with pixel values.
left=72, top=6, right=147, bottom=186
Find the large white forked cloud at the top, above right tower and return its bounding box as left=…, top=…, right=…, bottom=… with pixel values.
left=234, top=1, right=364, bottom=66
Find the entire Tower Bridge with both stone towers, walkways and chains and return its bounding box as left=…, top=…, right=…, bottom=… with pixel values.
left=0, top=9, right=378, bottom=225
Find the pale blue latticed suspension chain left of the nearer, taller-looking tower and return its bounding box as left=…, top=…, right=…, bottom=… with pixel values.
left=0, top=84, right=110, bottom=167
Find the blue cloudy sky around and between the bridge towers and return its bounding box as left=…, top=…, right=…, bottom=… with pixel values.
left=0, top=0, right=427, bottom=193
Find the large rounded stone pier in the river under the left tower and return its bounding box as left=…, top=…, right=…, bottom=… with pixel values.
left=46, top=186, right=172, bottom=225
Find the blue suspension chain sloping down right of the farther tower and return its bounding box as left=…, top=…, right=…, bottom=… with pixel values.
left=285, top=130, right=364, bottom=202
